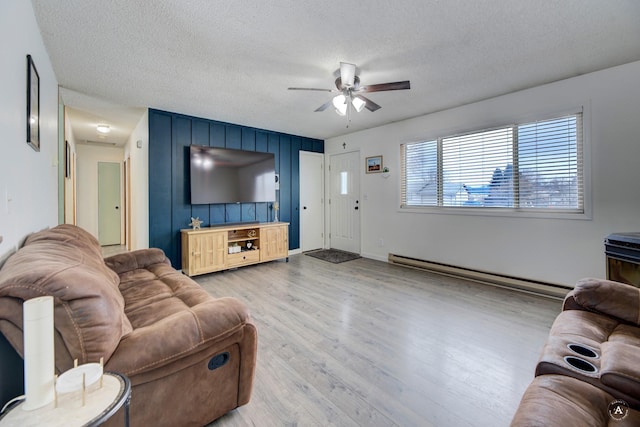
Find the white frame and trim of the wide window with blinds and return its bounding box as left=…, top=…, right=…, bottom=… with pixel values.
left=397, top=107, right=592, bottom=220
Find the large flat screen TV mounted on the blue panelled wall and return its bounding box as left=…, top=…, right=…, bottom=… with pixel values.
left=189, top=145, right=276, bottom=205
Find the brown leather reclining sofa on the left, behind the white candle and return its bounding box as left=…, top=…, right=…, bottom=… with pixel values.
left=0, top=225, right=257, bottom=426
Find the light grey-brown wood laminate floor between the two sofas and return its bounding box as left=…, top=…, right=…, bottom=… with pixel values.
left=196, top=254, right=561, bottom=427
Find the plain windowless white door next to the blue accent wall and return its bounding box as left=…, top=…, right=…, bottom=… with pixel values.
left=300, top=151, right=324, bottom=252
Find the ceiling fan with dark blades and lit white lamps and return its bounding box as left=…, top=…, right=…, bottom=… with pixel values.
left=289, top=62, right=411, bottom=123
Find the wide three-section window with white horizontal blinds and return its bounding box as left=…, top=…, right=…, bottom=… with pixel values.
left=401, top=113, right=584, bottom=213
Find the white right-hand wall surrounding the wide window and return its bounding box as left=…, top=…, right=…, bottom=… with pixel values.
left=325, top=62, right=640, bottom=286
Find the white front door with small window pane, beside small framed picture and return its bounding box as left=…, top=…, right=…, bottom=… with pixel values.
left=329, top=151, right=360, bottom=254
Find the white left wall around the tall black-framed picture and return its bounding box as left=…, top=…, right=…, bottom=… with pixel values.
left=0, top=0, right=58, bottom=256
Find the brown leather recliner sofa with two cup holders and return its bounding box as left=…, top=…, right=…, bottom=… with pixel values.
left=511, top=278, right=640, bottom=427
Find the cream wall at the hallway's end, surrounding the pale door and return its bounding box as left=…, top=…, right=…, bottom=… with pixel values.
left=76, top=144, right=124, bottom=242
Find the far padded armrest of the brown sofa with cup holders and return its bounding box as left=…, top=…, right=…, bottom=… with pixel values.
left=562, top=278, right=640, bottom=325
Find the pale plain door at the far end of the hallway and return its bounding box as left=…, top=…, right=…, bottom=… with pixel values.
left=98, top=162, right=122, bottom=246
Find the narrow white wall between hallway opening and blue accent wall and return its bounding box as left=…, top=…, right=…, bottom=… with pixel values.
left=124, top=110, right=149, bottom=250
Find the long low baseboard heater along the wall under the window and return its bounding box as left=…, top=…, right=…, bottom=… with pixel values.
left=389, top=254, right=571, bottom=299
